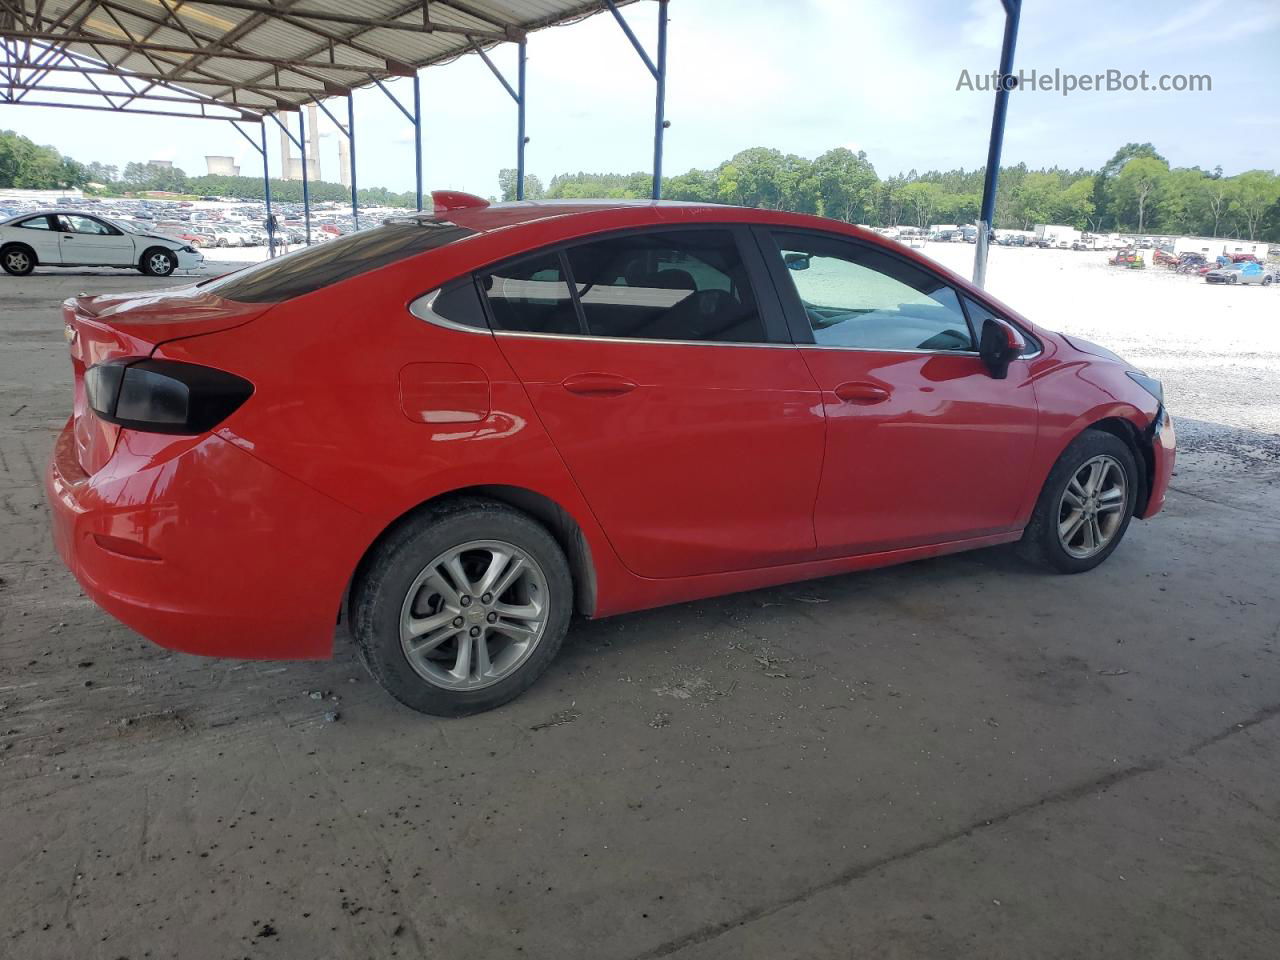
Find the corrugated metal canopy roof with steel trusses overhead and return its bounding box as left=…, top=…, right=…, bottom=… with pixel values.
left=0, top=0, right=632, bottom=120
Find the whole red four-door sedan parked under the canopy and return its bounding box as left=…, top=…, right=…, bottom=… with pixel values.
left=47, top=193, right=1174, bottom=714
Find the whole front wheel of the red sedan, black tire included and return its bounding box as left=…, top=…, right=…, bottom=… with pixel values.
left=1018, top=430, right=1142, bottom=573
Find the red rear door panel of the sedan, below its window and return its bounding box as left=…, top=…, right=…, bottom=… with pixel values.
left=498, top=334, right=824, bottom=577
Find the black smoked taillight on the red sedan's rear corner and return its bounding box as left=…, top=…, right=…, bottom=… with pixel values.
left=84, top=357, right=253, bottom=435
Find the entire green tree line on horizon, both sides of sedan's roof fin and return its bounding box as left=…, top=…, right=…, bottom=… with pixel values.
left=0, top=131, right=1280, bottom=242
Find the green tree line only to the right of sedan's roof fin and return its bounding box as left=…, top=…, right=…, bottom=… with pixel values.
left=498, top=143, right=1280, bottom=242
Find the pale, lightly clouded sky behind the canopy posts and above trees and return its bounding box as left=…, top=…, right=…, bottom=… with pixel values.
left=10, top=0, right=1280, bottom=196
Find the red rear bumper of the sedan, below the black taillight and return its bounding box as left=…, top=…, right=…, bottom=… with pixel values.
left=46, top=422, right=362, bottom=659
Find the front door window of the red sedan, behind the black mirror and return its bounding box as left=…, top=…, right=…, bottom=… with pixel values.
left=776, top=233, right=975, bottom=351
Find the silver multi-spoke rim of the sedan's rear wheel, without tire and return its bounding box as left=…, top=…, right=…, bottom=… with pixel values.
left=401, top=540, right=550, bottom=690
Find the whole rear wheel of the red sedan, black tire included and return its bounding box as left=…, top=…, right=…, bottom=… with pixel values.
left=351, top=498, right=573, bottom=717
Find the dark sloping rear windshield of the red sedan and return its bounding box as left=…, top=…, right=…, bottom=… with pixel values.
left=200, top=218, right=475, bottom=303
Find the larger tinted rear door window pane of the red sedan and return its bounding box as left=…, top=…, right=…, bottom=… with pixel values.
left=567, top=229, right=767, bottom=343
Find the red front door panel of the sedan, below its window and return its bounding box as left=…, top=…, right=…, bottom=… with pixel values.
left=801, top=347, right=1037, bottom=556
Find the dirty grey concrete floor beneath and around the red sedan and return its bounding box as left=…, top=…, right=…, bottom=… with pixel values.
left=0, top=264, right=1280, bottom=960
